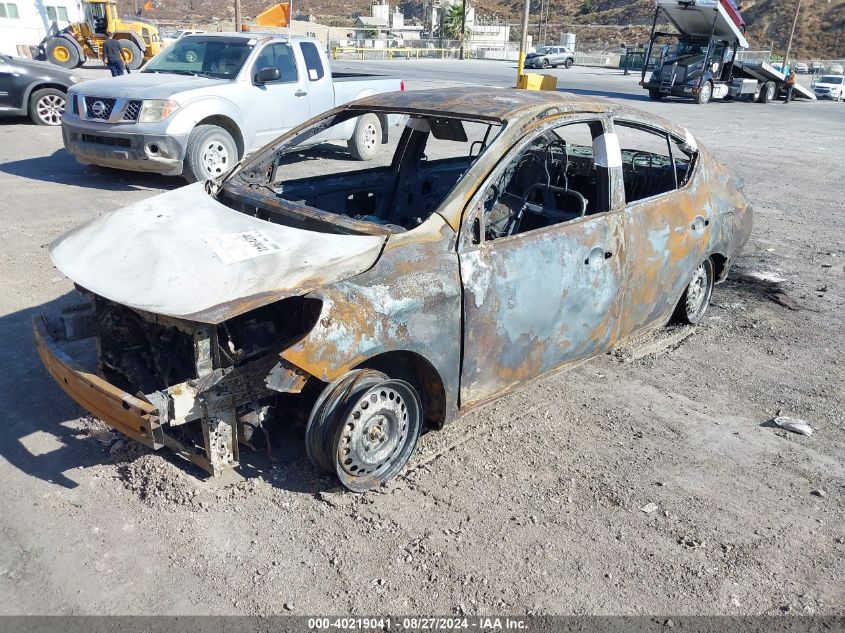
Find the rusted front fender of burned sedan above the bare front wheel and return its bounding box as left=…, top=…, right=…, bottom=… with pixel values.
left=281, top=213, right=461, bottom=421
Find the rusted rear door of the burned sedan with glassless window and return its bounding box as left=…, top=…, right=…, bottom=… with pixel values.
left=614, top=119, right=713, bottom=337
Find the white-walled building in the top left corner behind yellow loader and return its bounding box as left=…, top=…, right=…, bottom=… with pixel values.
left=0, top=0, right=80, bottom=55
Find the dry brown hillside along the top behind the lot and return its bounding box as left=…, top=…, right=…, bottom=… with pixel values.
left=135, top=0, right=845, bottom=59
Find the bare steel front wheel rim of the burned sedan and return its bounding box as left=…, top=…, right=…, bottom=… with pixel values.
left=333, top=380, right=422, bottom=492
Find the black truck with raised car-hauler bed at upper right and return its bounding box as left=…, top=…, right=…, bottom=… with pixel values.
left=640, top=0, right=816, bottom=104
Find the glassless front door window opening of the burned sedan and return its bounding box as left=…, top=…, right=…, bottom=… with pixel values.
left=483, top=121, right=610, bottom=240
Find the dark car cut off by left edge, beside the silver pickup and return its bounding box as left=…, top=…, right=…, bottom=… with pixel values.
left=0, top=55, right=82, bottom=125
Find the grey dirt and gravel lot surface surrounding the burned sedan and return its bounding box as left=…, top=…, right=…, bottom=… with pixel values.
left=0, top=62, right=845, bottom=615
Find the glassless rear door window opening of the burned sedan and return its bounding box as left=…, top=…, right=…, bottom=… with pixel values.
left=614, top=121, right=692, bottom=204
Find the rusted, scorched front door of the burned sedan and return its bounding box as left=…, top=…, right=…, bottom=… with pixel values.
left=459, top=120, right=625, bottom=407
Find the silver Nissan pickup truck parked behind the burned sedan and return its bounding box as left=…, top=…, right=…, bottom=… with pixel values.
left=62, top=33, right=404, bottom=182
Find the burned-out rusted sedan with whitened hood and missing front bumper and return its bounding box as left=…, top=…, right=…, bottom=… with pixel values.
left=34, top=87, right=752, bottom=491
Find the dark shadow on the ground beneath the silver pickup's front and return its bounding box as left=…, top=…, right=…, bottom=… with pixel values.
left=0, top=149, right=185, bottom=191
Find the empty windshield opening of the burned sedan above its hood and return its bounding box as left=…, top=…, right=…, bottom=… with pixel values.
left=223, top=110, right=502, bottom=234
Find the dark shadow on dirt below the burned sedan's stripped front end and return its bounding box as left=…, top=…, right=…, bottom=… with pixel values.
left=0, top=291, right=339, bottom=494
